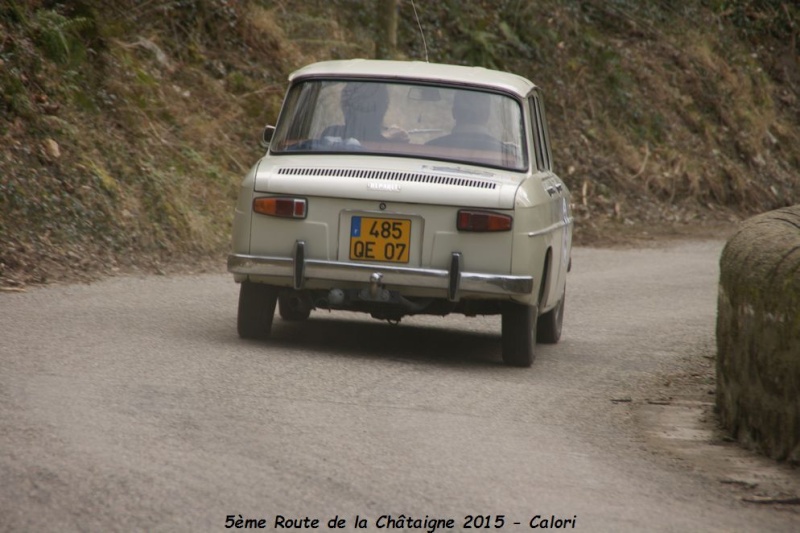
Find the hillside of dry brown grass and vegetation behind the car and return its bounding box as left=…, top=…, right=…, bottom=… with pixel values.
left=0, top=0, right=800, bottom=286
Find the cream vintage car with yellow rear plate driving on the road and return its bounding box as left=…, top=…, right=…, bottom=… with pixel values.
left=228, top=60, right=572, bottom=366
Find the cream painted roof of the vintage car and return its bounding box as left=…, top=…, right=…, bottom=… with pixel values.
left=289, top=59, right=535, bottom=97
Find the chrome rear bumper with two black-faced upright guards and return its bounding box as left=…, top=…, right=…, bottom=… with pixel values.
left=228, top=241, right=533, bottom=301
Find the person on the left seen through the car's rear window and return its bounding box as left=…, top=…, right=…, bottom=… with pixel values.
left=322, top=82, right=408, bottom=142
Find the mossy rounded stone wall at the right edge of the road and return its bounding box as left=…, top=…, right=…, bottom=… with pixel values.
left=716, top=205, right=800, bottom=463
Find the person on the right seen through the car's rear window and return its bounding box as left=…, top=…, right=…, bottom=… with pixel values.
left=425, top=91, right=501, bottom=150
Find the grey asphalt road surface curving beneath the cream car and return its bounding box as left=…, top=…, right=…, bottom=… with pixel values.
left=0, top=242, right=800, bottom=532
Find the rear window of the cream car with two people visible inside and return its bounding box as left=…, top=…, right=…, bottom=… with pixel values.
left=270, top=80, right=528, bottom=171
